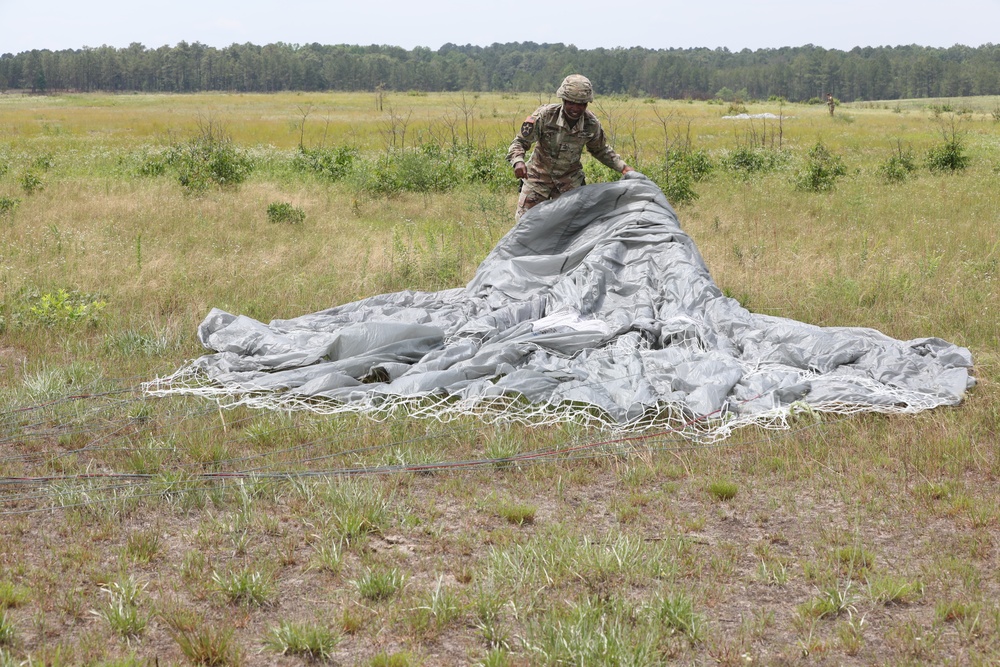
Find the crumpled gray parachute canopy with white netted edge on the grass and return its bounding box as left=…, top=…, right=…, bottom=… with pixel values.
left=147, top=173, right=974, bottom=438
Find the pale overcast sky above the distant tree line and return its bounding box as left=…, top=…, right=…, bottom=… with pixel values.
left=0, top=0, right=1000, bottom=53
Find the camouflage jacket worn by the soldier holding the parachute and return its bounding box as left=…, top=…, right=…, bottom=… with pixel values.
left=507, top=104, right=625, bottom=192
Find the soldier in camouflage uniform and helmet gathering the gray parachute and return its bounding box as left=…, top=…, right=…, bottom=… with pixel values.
left=507, top=74, right=633, bottom=220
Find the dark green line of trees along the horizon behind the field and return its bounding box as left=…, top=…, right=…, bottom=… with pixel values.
left=0, top=42, right=1000, bottom=101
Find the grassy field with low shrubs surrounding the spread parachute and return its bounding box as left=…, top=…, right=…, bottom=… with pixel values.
left=0, top=94, right=1000, bottom=666
